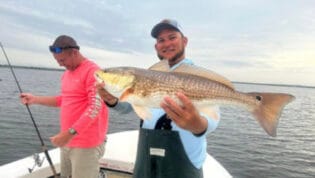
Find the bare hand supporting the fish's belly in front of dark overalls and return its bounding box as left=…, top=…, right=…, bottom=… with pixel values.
left=160, top=92, right=208, bottom=134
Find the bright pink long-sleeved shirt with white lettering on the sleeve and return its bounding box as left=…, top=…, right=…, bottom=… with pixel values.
left=56, top=59, right=108, bottom=148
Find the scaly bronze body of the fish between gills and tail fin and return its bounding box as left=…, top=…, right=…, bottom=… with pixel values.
left=134, top=70, right=252, bottom=105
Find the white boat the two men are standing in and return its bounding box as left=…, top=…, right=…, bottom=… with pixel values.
left=0, top=130, right=232, bottom=178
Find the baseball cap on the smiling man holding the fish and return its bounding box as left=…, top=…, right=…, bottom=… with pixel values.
left=151, top=19, right=183, bottom=38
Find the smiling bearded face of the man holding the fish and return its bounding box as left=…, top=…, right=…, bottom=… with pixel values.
left=155, top=29, right=187, bottom=66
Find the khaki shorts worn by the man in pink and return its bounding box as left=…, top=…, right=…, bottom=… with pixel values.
left=60, top=143, right=105, bottom=178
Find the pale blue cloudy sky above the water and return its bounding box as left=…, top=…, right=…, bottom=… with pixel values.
left=0, top=0, right=315, bottom=86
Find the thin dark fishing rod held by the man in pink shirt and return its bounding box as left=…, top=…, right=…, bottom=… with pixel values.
left=0, top=42, right=58, bottom=178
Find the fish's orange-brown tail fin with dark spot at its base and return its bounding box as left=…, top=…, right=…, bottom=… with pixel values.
left=248, top=93, right=295, bottom=137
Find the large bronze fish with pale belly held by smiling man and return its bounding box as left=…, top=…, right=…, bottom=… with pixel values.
left=95, top=62, right=295, bottom=136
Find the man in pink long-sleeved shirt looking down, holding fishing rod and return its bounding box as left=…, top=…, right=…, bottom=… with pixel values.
left=21, top=35, right=108, bottom=178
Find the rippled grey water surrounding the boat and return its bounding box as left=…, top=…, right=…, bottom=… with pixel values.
left=0, top=67, right=315, bottom=178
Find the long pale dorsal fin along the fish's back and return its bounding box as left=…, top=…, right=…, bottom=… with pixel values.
left=173, top=63, right=234, bottom=90
